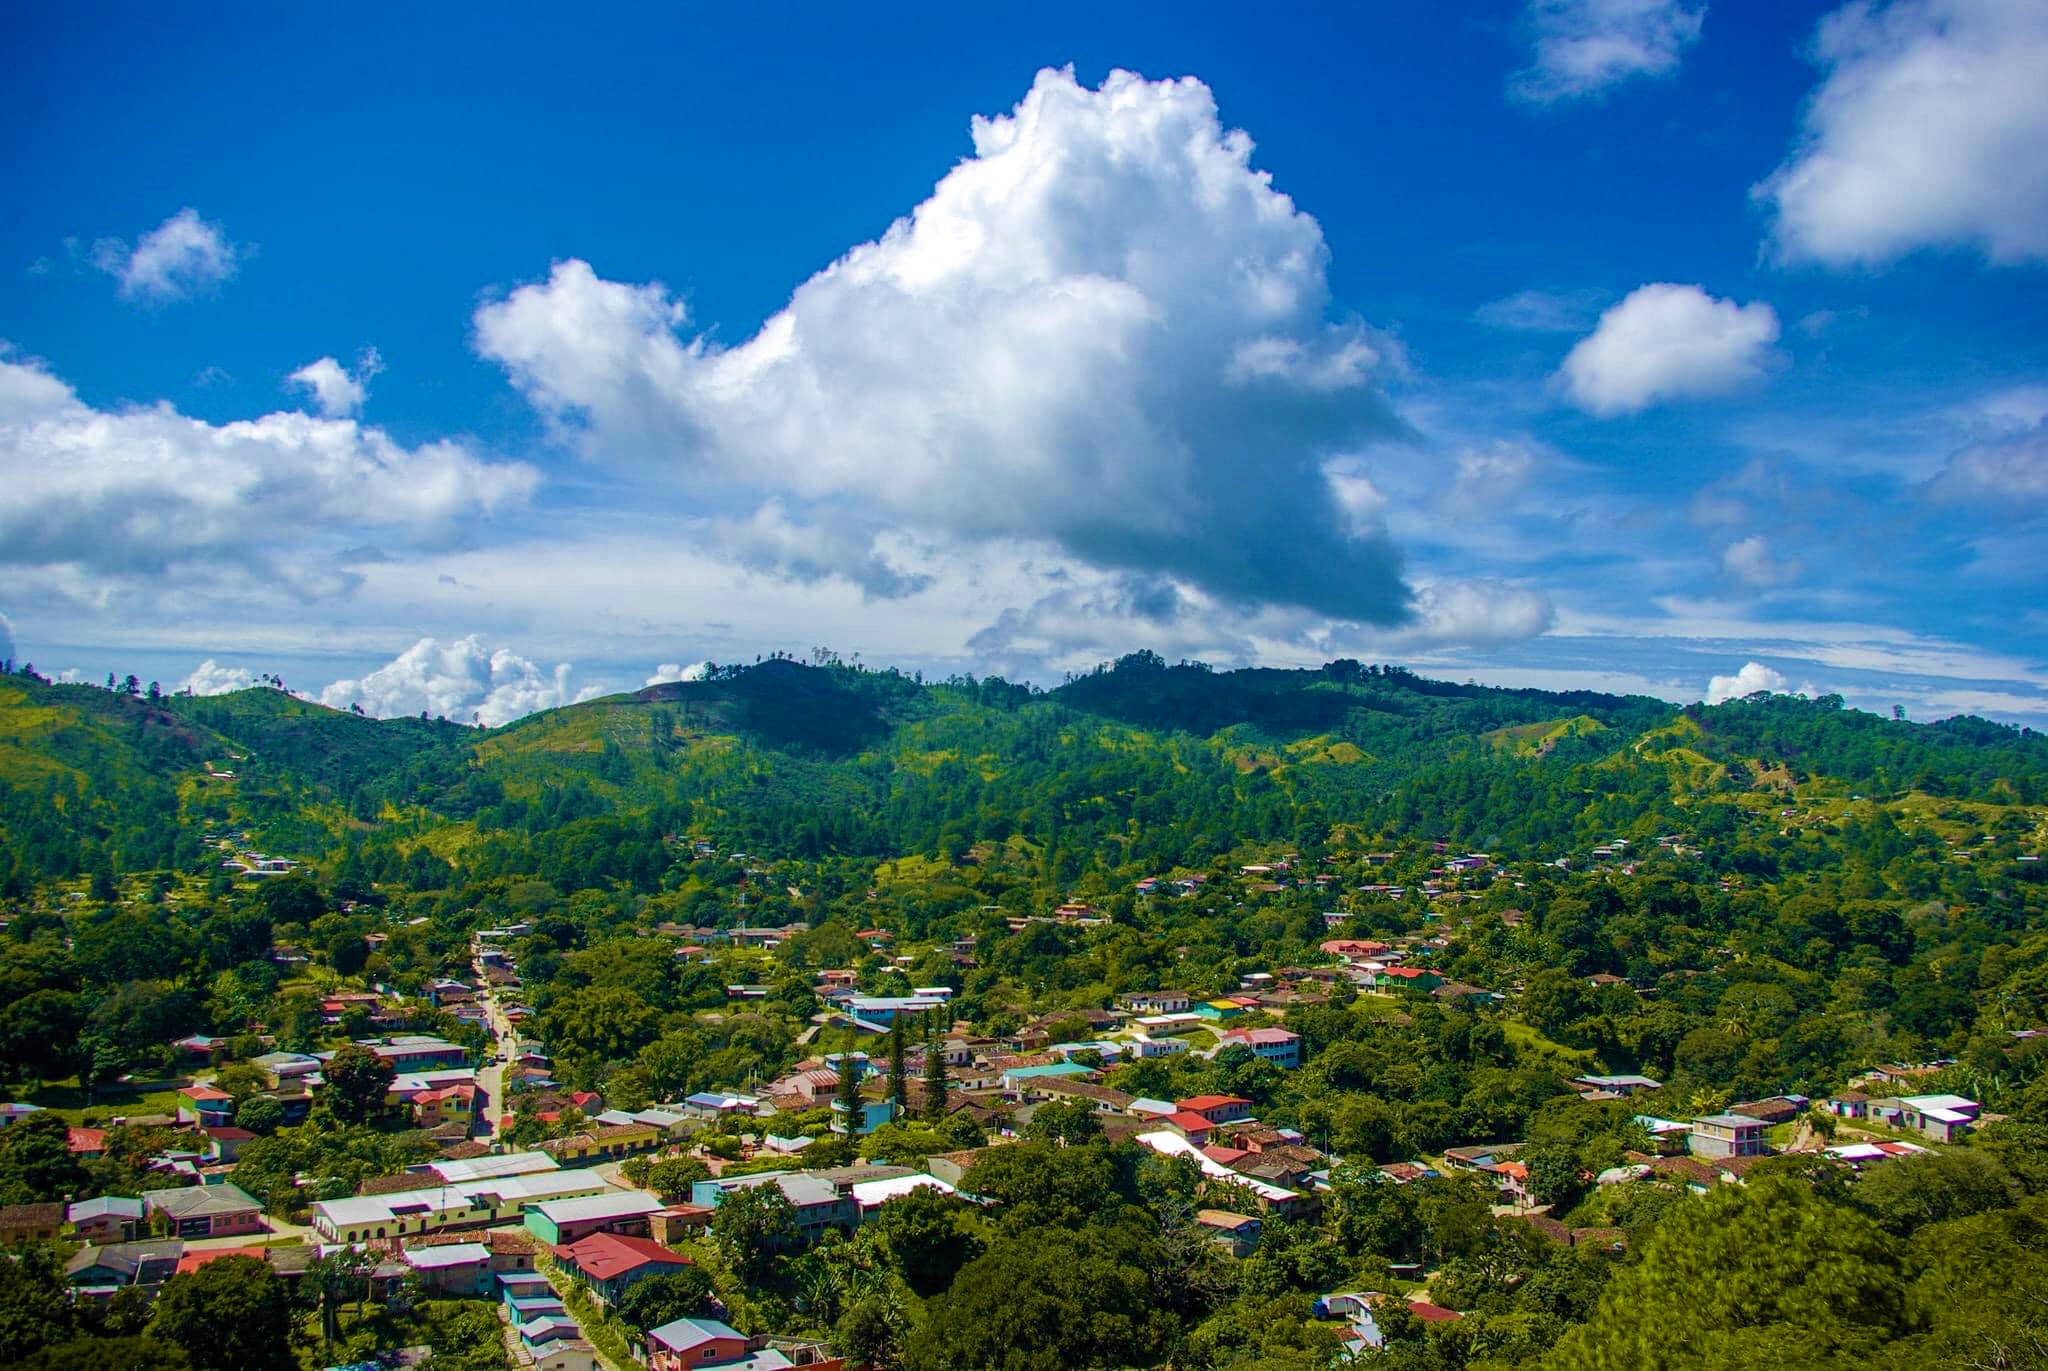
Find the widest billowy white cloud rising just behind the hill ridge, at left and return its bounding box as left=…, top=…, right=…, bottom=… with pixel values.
left=319, top=633, right=604, bottom=728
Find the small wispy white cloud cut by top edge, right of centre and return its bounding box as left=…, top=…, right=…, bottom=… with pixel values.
left=1507, top=0, right=1706, bottom=105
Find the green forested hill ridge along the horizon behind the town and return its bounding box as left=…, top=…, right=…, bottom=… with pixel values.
left=0, top=654, right=2048, bottom=893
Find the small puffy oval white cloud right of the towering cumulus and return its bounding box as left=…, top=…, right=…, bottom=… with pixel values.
left=1559, top=283, right=1778, bottom=416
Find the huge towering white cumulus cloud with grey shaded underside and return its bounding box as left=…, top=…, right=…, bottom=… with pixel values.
left=475, top=70, right=1411, bottom=623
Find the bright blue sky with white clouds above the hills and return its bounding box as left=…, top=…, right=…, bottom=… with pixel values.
left=0, top=0, right=2048, bottom=725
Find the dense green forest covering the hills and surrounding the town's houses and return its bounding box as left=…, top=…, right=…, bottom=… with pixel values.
left=0, top=652, right=2048, bottom=1371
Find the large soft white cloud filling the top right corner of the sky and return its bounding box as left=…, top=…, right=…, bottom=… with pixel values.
left=1755, top=0, right=2048, bottom=266
